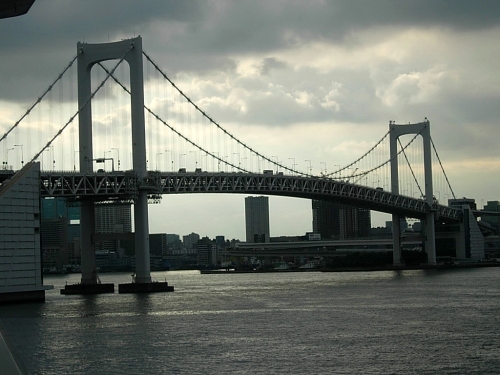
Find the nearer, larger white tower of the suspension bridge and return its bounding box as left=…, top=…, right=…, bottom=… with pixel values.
left=77, top=36, right=151, bottom=284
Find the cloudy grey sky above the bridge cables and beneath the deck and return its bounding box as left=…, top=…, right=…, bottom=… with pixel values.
left=0, top=0, right=500, bottom=239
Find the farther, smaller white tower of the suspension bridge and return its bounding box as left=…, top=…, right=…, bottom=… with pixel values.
left=389, top=119, right=436, bottom=265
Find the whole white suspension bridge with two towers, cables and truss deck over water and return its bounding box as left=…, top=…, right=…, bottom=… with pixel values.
left=0, top=37, right=474, bottom=294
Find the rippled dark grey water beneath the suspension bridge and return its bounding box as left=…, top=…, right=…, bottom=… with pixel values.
left=0, top=268, right=500, bottom=375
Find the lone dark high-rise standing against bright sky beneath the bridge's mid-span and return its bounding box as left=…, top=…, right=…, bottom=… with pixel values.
left=245, top=197, right=270, bottom=242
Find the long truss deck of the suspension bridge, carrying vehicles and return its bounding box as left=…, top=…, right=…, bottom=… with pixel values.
left=40, top=171, right=462, bottom=221
